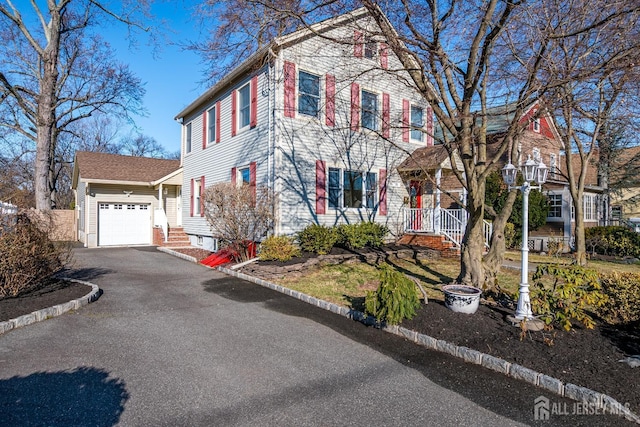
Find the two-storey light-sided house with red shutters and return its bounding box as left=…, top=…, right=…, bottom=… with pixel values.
left=176, top=9, right=433, bottom=250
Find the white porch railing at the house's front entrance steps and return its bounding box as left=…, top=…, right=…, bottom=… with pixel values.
left=404, top=208, right=493, bottom=247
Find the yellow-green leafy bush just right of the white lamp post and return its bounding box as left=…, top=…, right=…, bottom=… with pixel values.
left=531, top=264, right=607, bottom=331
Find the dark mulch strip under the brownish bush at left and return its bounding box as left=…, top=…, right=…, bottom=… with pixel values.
left=0, top=280, right=91, bottom=322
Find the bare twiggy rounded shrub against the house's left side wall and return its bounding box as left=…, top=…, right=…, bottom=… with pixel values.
left=201, top=182, right=275, bottom=259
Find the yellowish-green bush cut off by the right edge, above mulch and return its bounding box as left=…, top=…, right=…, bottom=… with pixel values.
left=597, top=273, right=640, bottom=325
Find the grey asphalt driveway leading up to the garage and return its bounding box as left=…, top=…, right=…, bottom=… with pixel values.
left=0, top=248, right=622, bottom=426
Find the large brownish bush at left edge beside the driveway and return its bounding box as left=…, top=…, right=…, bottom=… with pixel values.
left=0, top=213, right=71, bottom=298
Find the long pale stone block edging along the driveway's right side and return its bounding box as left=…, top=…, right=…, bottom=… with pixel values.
left=217, top=267, right=640, bottom=424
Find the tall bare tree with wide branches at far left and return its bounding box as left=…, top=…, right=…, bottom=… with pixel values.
left=0, top=0, right=148, bottom=210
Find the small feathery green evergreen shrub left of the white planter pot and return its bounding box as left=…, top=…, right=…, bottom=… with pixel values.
left=364, top=264, right=420, bottom=325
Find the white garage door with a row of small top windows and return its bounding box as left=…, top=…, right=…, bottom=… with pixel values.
left=98, top=203, right=151, bottom=246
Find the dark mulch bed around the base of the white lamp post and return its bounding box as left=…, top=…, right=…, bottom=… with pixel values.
left=402, top=301, right=640, bottom=414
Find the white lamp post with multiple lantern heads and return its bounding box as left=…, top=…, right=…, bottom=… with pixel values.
left=502, top=156, right=549, bottom=320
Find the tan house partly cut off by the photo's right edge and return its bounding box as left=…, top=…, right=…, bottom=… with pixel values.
left=609, top=146, right=640, bottom=232
